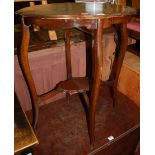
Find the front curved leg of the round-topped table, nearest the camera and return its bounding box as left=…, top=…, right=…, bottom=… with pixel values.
left=89, top=19, right=103, bottom=146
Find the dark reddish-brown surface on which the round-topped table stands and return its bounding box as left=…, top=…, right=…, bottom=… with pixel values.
left=28, top=86, right=140, bottom=155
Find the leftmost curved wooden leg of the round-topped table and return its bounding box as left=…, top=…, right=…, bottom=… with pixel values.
left=18, top=19, right=39, bottom=128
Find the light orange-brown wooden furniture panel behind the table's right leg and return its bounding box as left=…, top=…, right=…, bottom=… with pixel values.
left=118, top=51, right=140, bottom=108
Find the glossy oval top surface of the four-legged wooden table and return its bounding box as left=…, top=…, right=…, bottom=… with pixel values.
left=16, top=3, right=136, bottom=19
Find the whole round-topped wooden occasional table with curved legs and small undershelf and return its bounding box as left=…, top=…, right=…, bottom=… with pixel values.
left=17, top=3, right=136, bottom=144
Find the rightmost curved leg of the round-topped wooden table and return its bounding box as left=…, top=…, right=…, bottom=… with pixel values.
left=110, top=23, right=128, bottom=106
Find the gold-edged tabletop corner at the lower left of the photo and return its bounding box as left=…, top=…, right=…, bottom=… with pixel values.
left=14, top=95, right=39, bottom=153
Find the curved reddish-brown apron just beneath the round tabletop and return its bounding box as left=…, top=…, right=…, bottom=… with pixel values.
left=23, top=16, right=130, bottom=29
